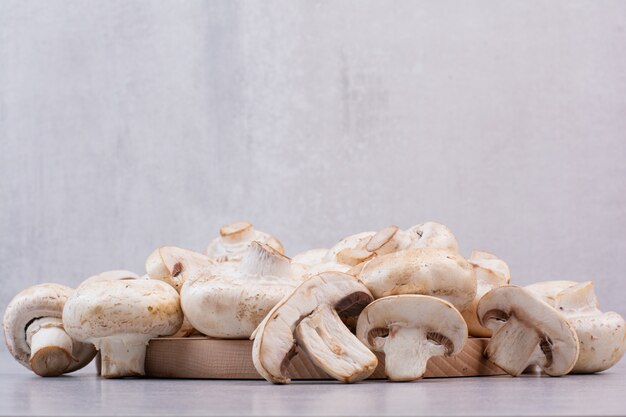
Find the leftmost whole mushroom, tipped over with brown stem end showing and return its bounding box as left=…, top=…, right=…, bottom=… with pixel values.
left=3, top=284, right=96, bottom=376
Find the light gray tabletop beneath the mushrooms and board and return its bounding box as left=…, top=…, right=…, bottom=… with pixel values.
left=0, top=350, right=626, bottom=416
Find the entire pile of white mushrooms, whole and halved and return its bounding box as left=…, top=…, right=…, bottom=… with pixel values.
left=3, top=222, right=626, bottom=384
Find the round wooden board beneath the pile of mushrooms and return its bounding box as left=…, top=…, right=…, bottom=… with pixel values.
left=146, top=337, right=504, bottom=379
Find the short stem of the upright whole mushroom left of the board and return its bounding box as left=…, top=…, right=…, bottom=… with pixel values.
left=98, top=334, right=151, bottom=378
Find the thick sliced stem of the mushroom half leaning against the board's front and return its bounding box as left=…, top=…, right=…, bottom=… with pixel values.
left=295, top=306, right=378, bottom=382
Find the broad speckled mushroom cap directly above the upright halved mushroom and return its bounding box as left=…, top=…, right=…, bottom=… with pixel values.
left=351, top=248, right=476, bottom=311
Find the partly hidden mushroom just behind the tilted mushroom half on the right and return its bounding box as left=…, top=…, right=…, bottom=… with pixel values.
left=461, top=250, right=511, bottom=337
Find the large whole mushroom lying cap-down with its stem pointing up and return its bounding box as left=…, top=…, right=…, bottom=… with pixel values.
left=181, top=242, right=304, bottom=339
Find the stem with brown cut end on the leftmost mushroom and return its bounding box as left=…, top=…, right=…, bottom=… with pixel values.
left=27, top=318, right=76, bottom=376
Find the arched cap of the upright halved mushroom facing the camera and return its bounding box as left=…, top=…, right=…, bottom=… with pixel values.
left=356, top=294, right=467, bottom=355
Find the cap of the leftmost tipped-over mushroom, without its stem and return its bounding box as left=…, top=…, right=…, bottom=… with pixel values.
left=3, top=284, right=96, bottom=373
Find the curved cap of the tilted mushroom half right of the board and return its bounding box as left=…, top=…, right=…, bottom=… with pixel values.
left=476, top=285, right=579, bottom=375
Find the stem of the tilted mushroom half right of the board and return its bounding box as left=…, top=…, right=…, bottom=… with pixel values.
left=485, top=316, right=541, bottom=376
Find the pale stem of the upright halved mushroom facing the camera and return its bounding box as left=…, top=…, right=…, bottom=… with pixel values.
left=382, top=326, right=446, bottom=381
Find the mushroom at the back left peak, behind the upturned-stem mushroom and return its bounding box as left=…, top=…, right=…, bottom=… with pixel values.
left=205, top=222, right=285, bottom=262
